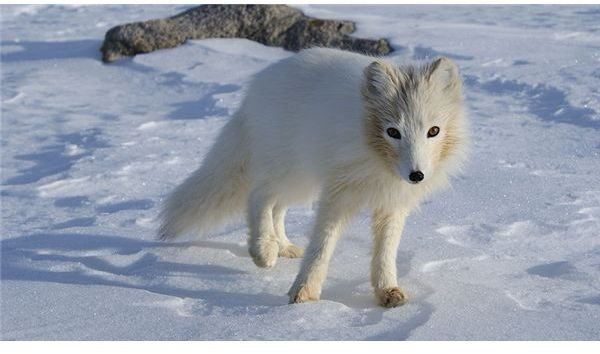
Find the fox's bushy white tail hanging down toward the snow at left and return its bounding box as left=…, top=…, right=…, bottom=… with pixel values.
left=158, top=112, right=250, bottom=240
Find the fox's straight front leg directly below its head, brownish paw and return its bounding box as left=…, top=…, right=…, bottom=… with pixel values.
left=371, top=209, right=407, bottom=307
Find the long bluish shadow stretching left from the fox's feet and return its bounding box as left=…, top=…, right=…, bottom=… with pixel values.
left=0, top=233, right=287, bottom=307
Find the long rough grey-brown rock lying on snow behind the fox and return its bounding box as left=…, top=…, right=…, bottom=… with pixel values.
left=100, top=5, right=392, bottom=62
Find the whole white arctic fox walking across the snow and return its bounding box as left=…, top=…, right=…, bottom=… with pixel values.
left=159, top=48, right=468, bottom=307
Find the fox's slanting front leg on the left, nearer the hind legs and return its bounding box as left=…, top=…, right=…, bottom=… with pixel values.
left=288, top=185, right=359, bottom=303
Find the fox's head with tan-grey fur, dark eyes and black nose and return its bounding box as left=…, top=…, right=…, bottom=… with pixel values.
left=362, top=58, right=467, bottom=184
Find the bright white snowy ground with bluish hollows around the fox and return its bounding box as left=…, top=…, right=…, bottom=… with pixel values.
left=0, top=6, right=600, bottom=340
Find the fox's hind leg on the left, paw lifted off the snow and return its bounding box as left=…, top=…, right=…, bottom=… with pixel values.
left=248, top=187, right=279, bottom=268
